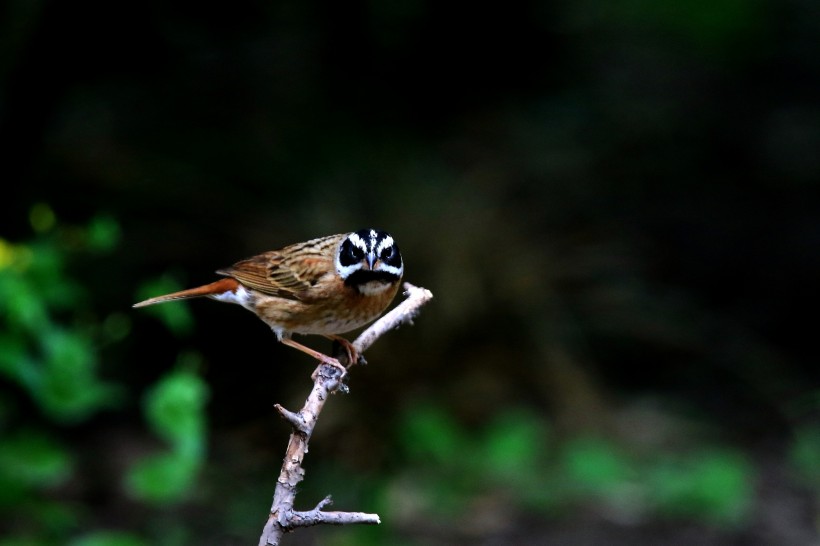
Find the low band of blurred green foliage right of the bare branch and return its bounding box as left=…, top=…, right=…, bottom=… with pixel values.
left=382, top=404, right=757, bottom=526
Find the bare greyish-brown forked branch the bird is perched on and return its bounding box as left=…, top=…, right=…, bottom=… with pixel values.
left=259, top=283, right=433, bottom=546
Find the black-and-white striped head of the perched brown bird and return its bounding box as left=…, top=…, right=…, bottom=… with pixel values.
left=336, top=229, right=404, bottom=293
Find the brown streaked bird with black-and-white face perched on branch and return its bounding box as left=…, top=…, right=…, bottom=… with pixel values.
left=134, top=228, right=404, bottom=379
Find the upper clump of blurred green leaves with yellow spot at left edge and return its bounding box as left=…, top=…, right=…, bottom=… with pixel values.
left=0, top=204, right=121, bottom=423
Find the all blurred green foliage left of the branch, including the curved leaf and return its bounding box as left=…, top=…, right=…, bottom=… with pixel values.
left=0, top=203, right=208, bottom=546
